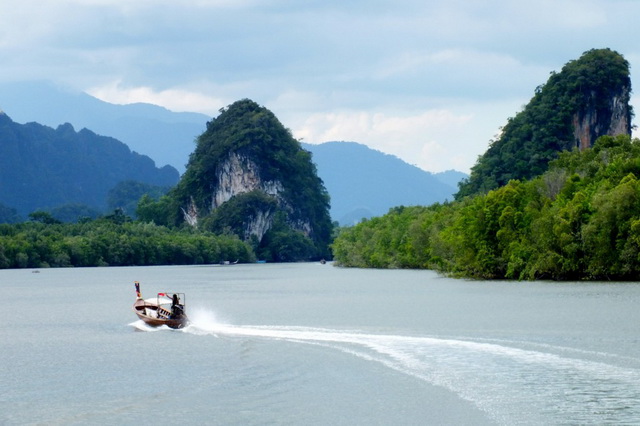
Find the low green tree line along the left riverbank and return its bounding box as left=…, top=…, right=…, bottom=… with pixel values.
left=0, top=215, right=255, bottom=268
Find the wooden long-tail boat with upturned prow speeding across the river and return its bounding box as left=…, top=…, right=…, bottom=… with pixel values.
left=133, top=281, right=189, bottom=329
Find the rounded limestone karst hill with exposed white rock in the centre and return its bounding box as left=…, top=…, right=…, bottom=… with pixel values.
left=174, top=99, right=332, bottom=261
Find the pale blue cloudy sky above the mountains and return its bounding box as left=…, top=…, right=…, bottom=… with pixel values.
left=0, top=0, right=640, bottom=172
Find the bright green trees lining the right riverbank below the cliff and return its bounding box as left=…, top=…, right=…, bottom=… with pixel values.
left=333, top=136, right=640, bottom=280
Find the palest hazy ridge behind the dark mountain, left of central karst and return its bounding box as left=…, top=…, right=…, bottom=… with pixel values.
left=0, top=81, right=211, bottom=173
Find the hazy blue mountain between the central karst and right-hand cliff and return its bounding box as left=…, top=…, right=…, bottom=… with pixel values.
left=302, top=142, right=466, bottom=225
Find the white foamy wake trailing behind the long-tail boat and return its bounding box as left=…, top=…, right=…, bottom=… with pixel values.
left=132, top=311, right=640, bottom=424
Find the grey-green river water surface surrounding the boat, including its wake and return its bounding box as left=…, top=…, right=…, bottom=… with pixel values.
left=0, top=263, right=640, bottom=425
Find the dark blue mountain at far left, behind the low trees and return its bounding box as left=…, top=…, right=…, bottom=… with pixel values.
left=0, top=113, right=179, bottom=216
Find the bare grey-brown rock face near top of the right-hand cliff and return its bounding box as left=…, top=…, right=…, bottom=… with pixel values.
left=573, top=85, right=631, bottom=151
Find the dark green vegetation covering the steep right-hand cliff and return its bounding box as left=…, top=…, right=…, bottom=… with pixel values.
left=456, top=49, right=632, bottom=200
